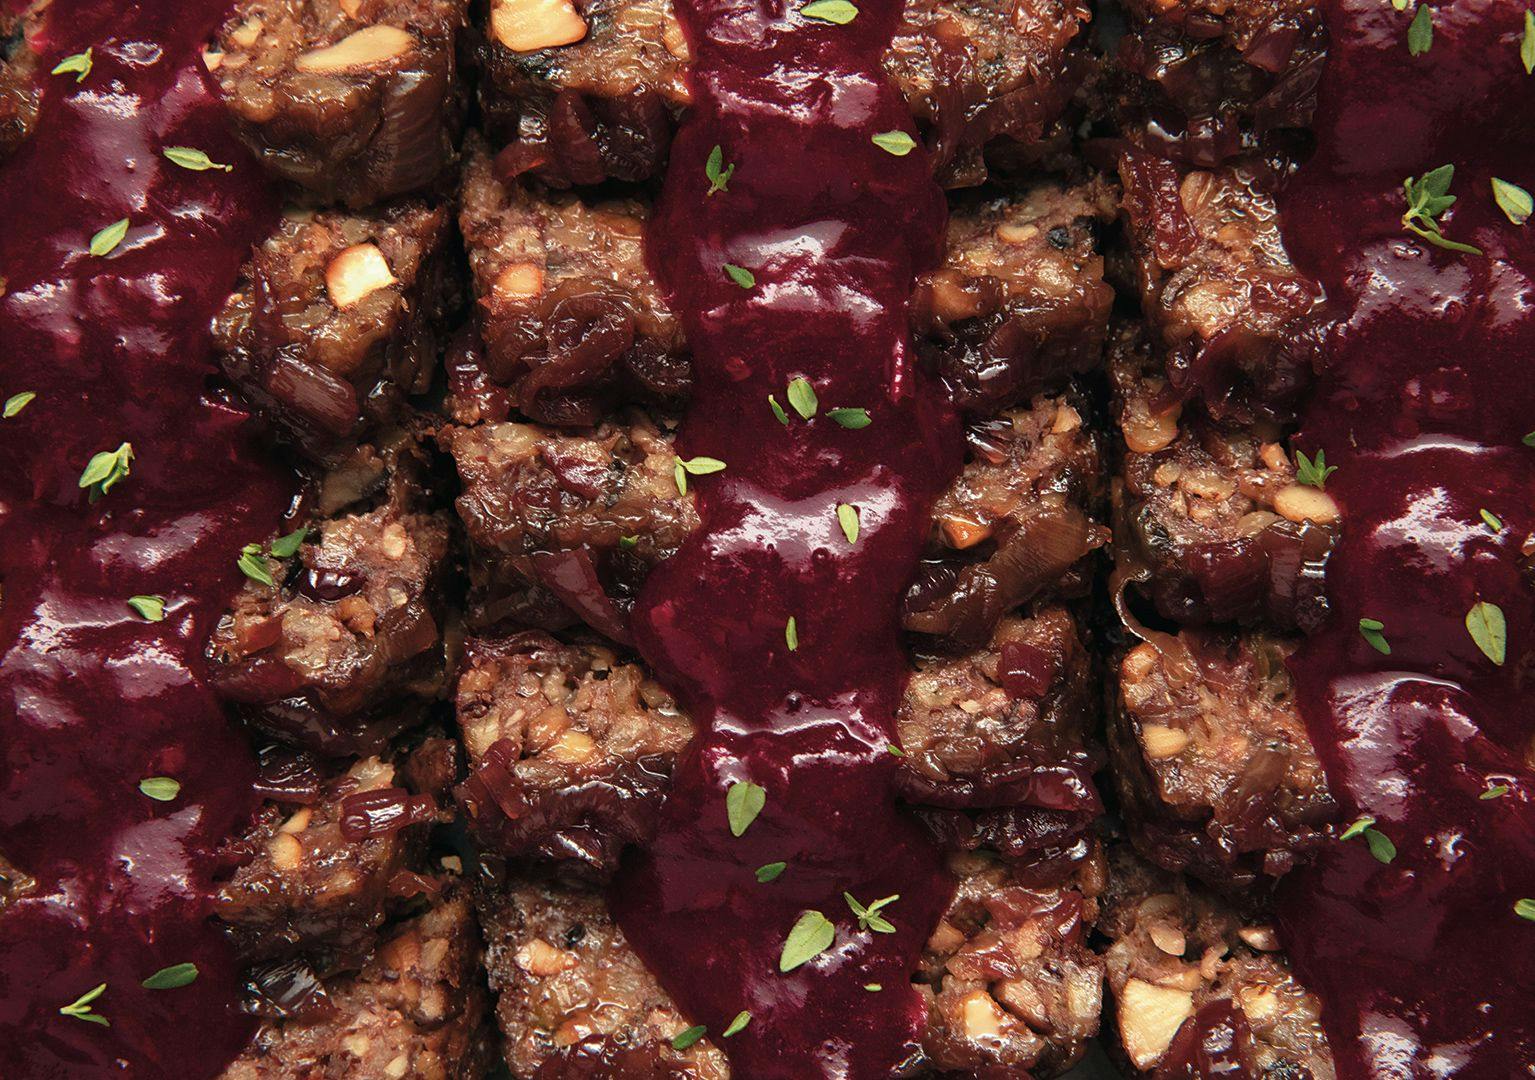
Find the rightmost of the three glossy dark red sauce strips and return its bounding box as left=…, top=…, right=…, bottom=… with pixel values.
left=1282, top=0, right=1535, bottom=1080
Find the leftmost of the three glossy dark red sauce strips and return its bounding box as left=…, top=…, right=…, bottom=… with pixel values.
left=0, top=0, right=293, bottom=1078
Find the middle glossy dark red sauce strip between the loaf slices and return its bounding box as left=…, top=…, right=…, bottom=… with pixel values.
left=614, top=0, right=961, bottom=1080
